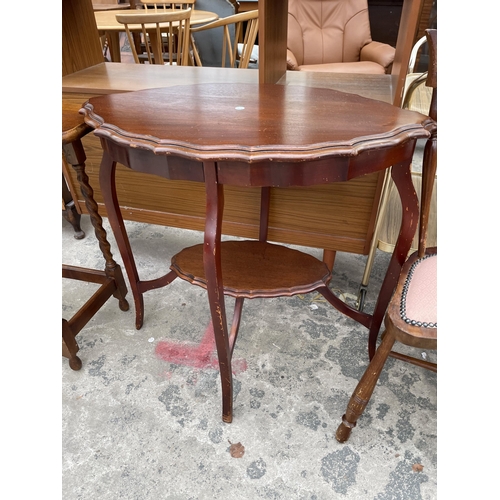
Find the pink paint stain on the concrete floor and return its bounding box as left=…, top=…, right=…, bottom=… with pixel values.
left=155, top=321, right=247, bottom=375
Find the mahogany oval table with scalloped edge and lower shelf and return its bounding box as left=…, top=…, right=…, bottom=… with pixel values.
left=80, top=83, right=436, bottom=422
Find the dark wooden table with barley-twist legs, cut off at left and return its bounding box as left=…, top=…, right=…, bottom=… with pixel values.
left=62, top=104, right=129, bottom=370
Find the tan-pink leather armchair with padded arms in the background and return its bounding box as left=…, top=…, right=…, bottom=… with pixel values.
left=287, top=0, right=395, bottom=74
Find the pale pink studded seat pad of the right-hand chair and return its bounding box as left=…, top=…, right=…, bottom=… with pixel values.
left=401, top=255, right=437, bottom=328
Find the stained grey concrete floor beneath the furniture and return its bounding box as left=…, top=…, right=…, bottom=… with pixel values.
left=62, top=209, right=437, bottom=500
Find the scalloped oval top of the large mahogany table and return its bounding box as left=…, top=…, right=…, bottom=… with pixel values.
left=84, top=83, right=433, bottom=162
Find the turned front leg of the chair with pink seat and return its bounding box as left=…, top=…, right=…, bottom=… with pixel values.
left=335, top=331, right=395, bottom=443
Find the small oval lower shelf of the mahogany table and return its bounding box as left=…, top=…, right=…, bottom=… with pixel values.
left=170, top=240, right=331, bottom=298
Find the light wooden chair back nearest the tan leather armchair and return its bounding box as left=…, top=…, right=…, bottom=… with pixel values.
left=191, top=10, right=259, bottom=68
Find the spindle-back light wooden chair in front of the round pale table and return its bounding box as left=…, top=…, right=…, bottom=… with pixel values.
left=116, top=8, right=192, bottom=66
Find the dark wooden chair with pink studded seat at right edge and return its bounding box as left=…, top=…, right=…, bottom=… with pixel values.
left=336, top=30, right=437, bottom=443
